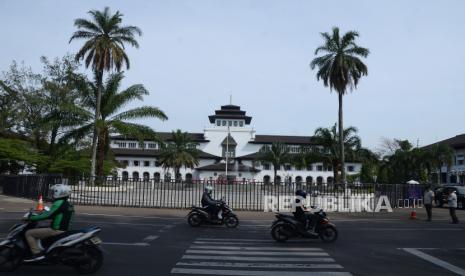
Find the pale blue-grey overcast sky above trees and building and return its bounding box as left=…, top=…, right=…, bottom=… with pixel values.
left=0, top=0, right=465, bottom=149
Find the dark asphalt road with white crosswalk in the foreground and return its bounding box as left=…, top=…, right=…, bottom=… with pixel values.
left=0, top=208, right=465, bottom=276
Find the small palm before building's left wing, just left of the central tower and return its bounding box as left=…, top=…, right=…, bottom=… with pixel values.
left=159, top=129, right=200, bottom=181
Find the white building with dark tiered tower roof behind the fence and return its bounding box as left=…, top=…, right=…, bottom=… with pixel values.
left=110, top=105, right=361, bottom=184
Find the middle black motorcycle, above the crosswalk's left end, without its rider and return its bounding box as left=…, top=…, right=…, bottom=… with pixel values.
left=187, top=198, right=239, bottom=228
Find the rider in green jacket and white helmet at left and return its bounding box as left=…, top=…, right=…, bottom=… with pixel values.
left=25, top=184, right=74, bottom=261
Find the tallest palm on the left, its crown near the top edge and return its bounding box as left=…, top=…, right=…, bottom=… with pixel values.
left=69, top=7, right=142, bottom=179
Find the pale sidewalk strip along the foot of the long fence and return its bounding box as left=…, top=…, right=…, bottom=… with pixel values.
left=0, top=195, right=465, bottom=221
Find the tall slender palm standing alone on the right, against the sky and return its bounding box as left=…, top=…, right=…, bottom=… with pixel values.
left=310, top=27, right=369, bottom=188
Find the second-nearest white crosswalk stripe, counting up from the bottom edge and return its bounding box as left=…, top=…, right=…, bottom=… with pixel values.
left=176, top=262, right=344, bottom=269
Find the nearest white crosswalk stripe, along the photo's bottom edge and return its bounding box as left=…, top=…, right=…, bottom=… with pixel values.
left=171, top=268, right=352, bottom=276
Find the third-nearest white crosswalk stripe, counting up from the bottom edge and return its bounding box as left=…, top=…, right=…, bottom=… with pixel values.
left=181, top=255, right=334, bottom=263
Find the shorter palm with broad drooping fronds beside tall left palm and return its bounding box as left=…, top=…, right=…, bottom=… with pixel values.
left=61, top=72, right=168, bottom=177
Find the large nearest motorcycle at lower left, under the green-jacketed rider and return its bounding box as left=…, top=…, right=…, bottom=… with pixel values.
left=0, top=210, right=103, bottom=274
